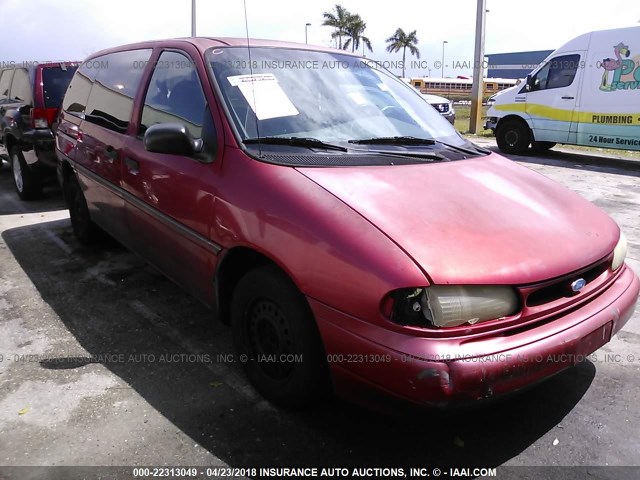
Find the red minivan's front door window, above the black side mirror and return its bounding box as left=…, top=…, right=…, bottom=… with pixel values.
left=139, top=51, right=207, bottom=138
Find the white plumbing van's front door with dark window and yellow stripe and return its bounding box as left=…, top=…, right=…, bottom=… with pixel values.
left=526, top=52, right=584, bottom=143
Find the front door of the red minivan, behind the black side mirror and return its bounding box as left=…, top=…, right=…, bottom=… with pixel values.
left=123, top=50, right=220, bottom=302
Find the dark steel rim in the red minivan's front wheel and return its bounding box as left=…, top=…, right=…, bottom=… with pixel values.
left=248, top=300, right=294, bottom=379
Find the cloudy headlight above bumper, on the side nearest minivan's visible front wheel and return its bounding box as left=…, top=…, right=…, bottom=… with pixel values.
left=384, top=285, right=519, bottom=328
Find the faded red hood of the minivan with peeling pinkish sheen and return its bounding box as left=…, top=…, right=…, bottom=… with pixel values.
left=298, top=154, right=620, bottom=285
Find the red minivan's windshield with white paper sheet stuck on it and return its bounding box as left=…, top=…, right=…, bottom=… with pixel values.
left=207, top=46, right=470, bottom=157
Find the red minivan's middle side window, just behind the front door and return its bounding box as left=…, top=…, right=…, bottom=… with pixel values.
left=84, top=49, right=151, bottom=133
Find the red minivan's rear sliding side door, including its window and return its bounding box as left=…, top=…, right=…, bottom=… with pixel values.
left=75, top=49, right=151, bottom=245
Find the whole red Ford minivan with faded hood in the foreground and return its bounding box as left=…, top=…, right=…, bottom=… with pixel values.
left=56, top=38, right=640, bottom=406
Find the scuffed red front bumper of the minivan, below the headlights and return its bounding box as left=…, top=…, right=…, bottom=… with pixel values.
left=309, top=266, right=640, bottom=406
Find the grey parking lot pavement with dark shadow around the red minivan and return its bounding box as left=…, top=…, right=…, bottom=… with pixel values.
left=0, top=152, right=640, bottom=478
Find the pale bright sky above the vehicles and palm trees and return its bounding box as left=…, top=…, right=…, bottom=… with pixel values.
left=0, top=0, right=640, bottom=77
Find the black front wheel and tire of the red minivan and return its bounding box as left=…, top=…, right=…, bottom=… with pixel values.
left=231, top=266, right=329, bottom=408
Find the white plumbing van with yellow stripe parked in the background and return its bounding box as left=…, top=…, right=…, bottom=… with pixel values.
left=485, top=27, right=640, bottom=154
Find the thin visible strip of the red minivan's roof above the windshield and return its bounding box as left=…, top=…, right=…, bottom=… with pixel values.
left=88, top=37, right=359, bottom=59
